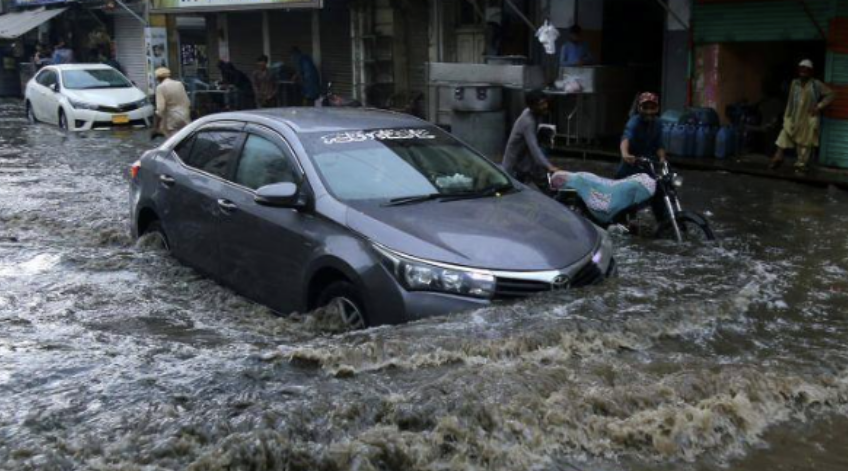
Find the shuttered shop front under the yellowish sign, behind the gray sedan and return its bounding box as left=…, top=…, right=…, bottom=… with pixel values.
left=153, top=0, right=353, bottom=114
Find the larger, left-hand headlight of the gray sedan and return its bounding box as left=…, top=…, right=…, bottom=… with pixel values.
left=374, top=244, right=495, bottom=299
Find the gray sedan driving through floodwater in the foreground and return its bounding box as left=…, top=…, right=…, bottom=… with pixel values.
left=130, top=108, right=615, bottom=327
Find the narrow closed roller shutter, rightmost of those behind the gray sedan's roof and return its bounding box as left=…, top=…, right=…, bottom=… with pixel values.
left=321, top=0, right=353, bottom=97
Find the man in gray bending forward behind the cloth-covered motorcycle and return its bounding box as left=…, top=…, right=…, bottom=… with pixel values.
left=503, top=90, right=559, bottom=185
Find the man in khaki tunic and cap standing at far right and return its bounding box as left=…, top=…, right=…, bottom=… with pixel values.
left=769, top=59, right=836, bottom=171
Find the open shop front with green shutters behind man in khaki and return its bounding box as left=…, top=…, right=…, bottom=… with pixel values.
left=692, top=0, right=848, bottom=167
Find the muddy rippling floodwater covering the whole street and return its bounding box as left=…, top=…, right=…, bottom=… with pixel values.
left=0, top=101, right=848, bottom=471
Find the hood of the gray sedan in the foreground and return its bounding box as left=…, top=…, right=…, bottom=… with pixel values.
left=346, top=190, right=600, bottom=271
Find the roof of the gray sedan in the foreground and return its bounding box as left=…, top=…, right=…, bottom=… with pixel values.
left=206, top=107, right=432, bottom=134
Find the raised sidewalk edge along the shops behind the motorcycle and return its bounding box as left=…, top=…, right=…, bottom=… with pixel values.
left=552, top=148, right=848, bottom=190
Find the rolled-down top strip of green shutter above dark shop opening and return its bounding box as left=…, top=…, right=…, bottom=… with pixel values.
left=693, top=0, right=836, bottom=43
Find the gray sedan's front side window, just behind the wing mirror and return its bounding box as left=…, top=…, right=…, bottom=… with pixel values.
left=235, top=134, right=300, bottom=190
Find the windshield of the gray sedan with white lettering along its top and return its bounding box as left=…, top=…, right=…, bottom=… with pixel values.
left=303, top=128, right=512, bottom=201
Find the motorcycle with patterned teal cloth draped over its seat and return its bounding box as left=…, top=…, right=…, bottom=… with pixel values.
left=548, top=158, right=715, bottom=242
